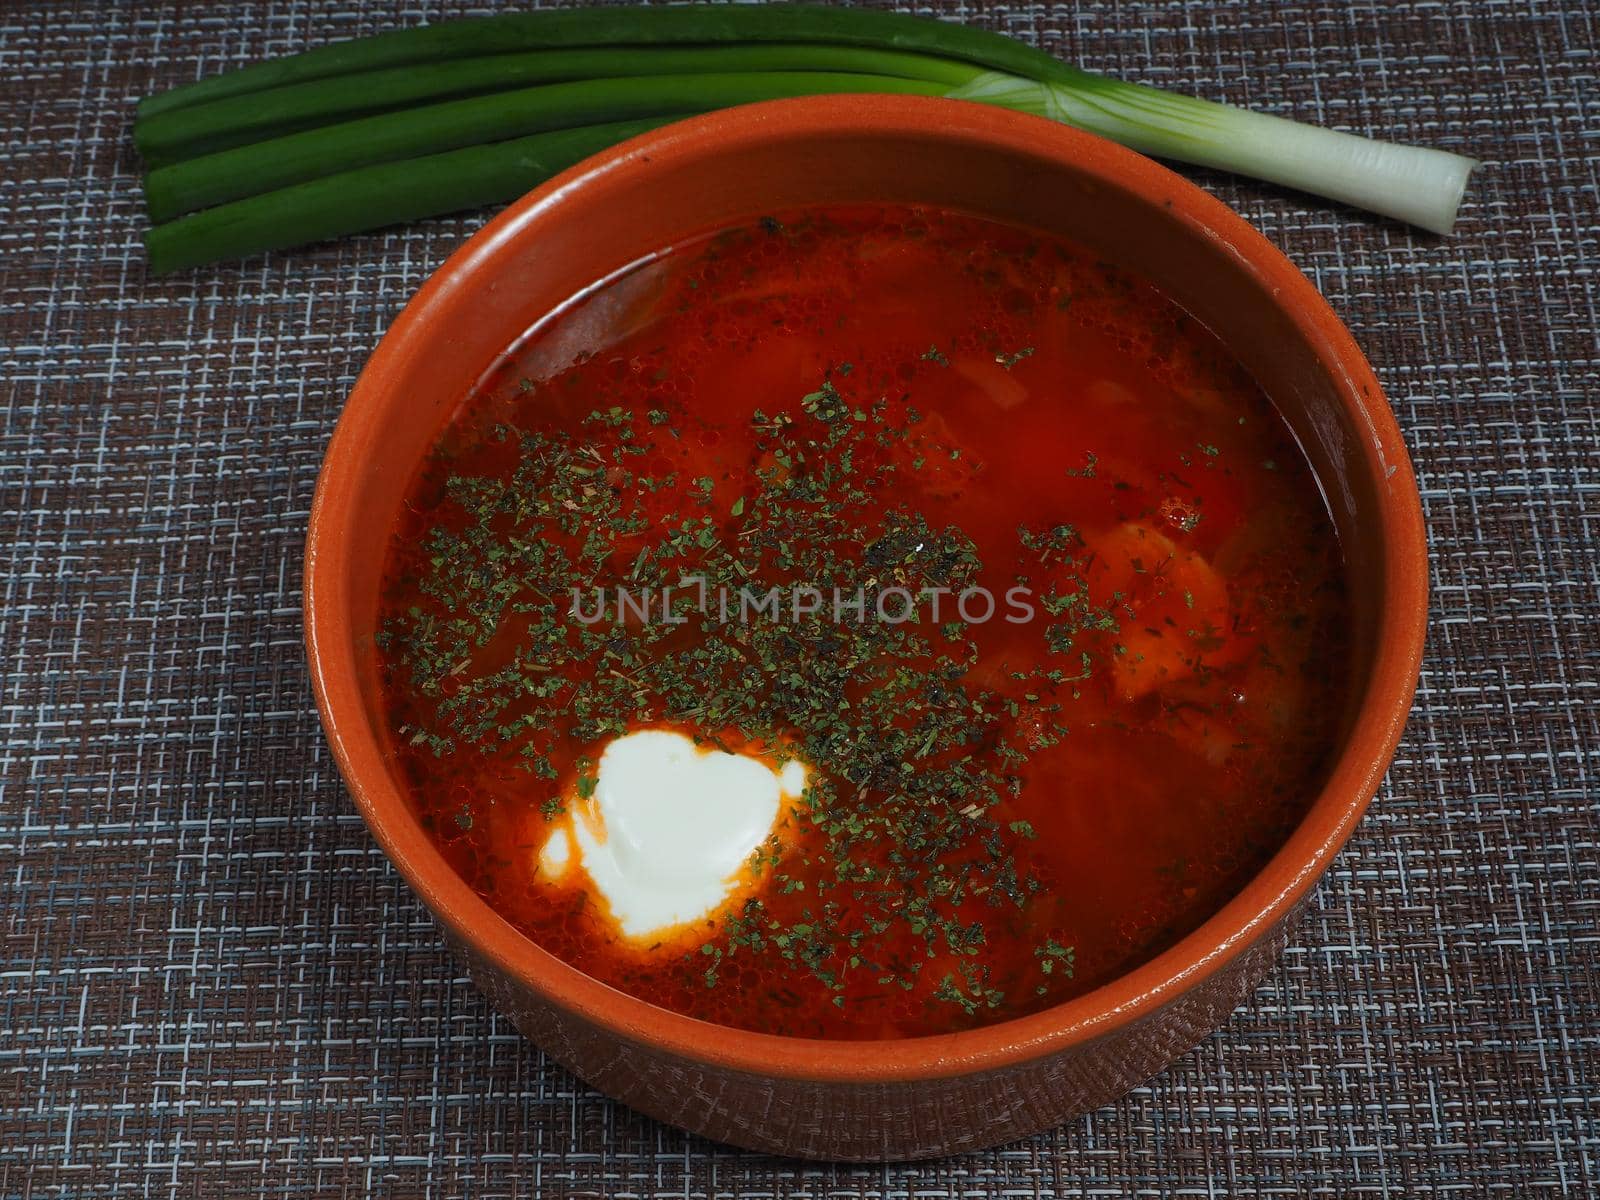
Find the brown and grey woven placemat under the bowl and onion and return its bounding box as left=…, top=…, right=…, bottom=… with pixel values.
left=0, top=0, right=1600, bottom=1200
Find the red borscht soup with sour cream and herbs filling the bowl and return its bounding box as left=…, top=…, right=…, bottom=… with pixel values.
left=379, top=206, right=1347, bottom=1038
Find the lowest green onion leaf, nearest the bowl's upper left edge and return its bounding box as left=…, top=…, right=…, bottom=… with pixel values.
left=144, top=112, right=675, bottom=275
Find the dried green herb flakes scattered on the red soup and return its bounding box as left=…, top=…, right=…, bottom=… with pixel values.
left=382, top=364, right=1115, bottom=1011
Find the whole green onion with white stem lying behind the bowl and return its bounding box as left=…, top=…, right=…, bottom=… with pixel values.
left=134, top=5, right=1477, bottom=274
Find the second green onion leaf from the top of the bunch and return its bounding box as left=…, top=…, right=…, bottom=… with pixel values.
left=134, top=43, right=979, bottom=165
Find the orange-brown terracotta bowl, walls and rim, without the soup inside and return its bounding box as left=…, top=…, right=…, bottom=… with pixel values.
left=306, top=96, right=1426, bottom=1160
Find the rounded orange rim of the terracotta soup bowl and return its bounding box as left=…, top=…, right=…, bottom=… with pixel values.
left=304, top=96, right=1427, bottom=1083
